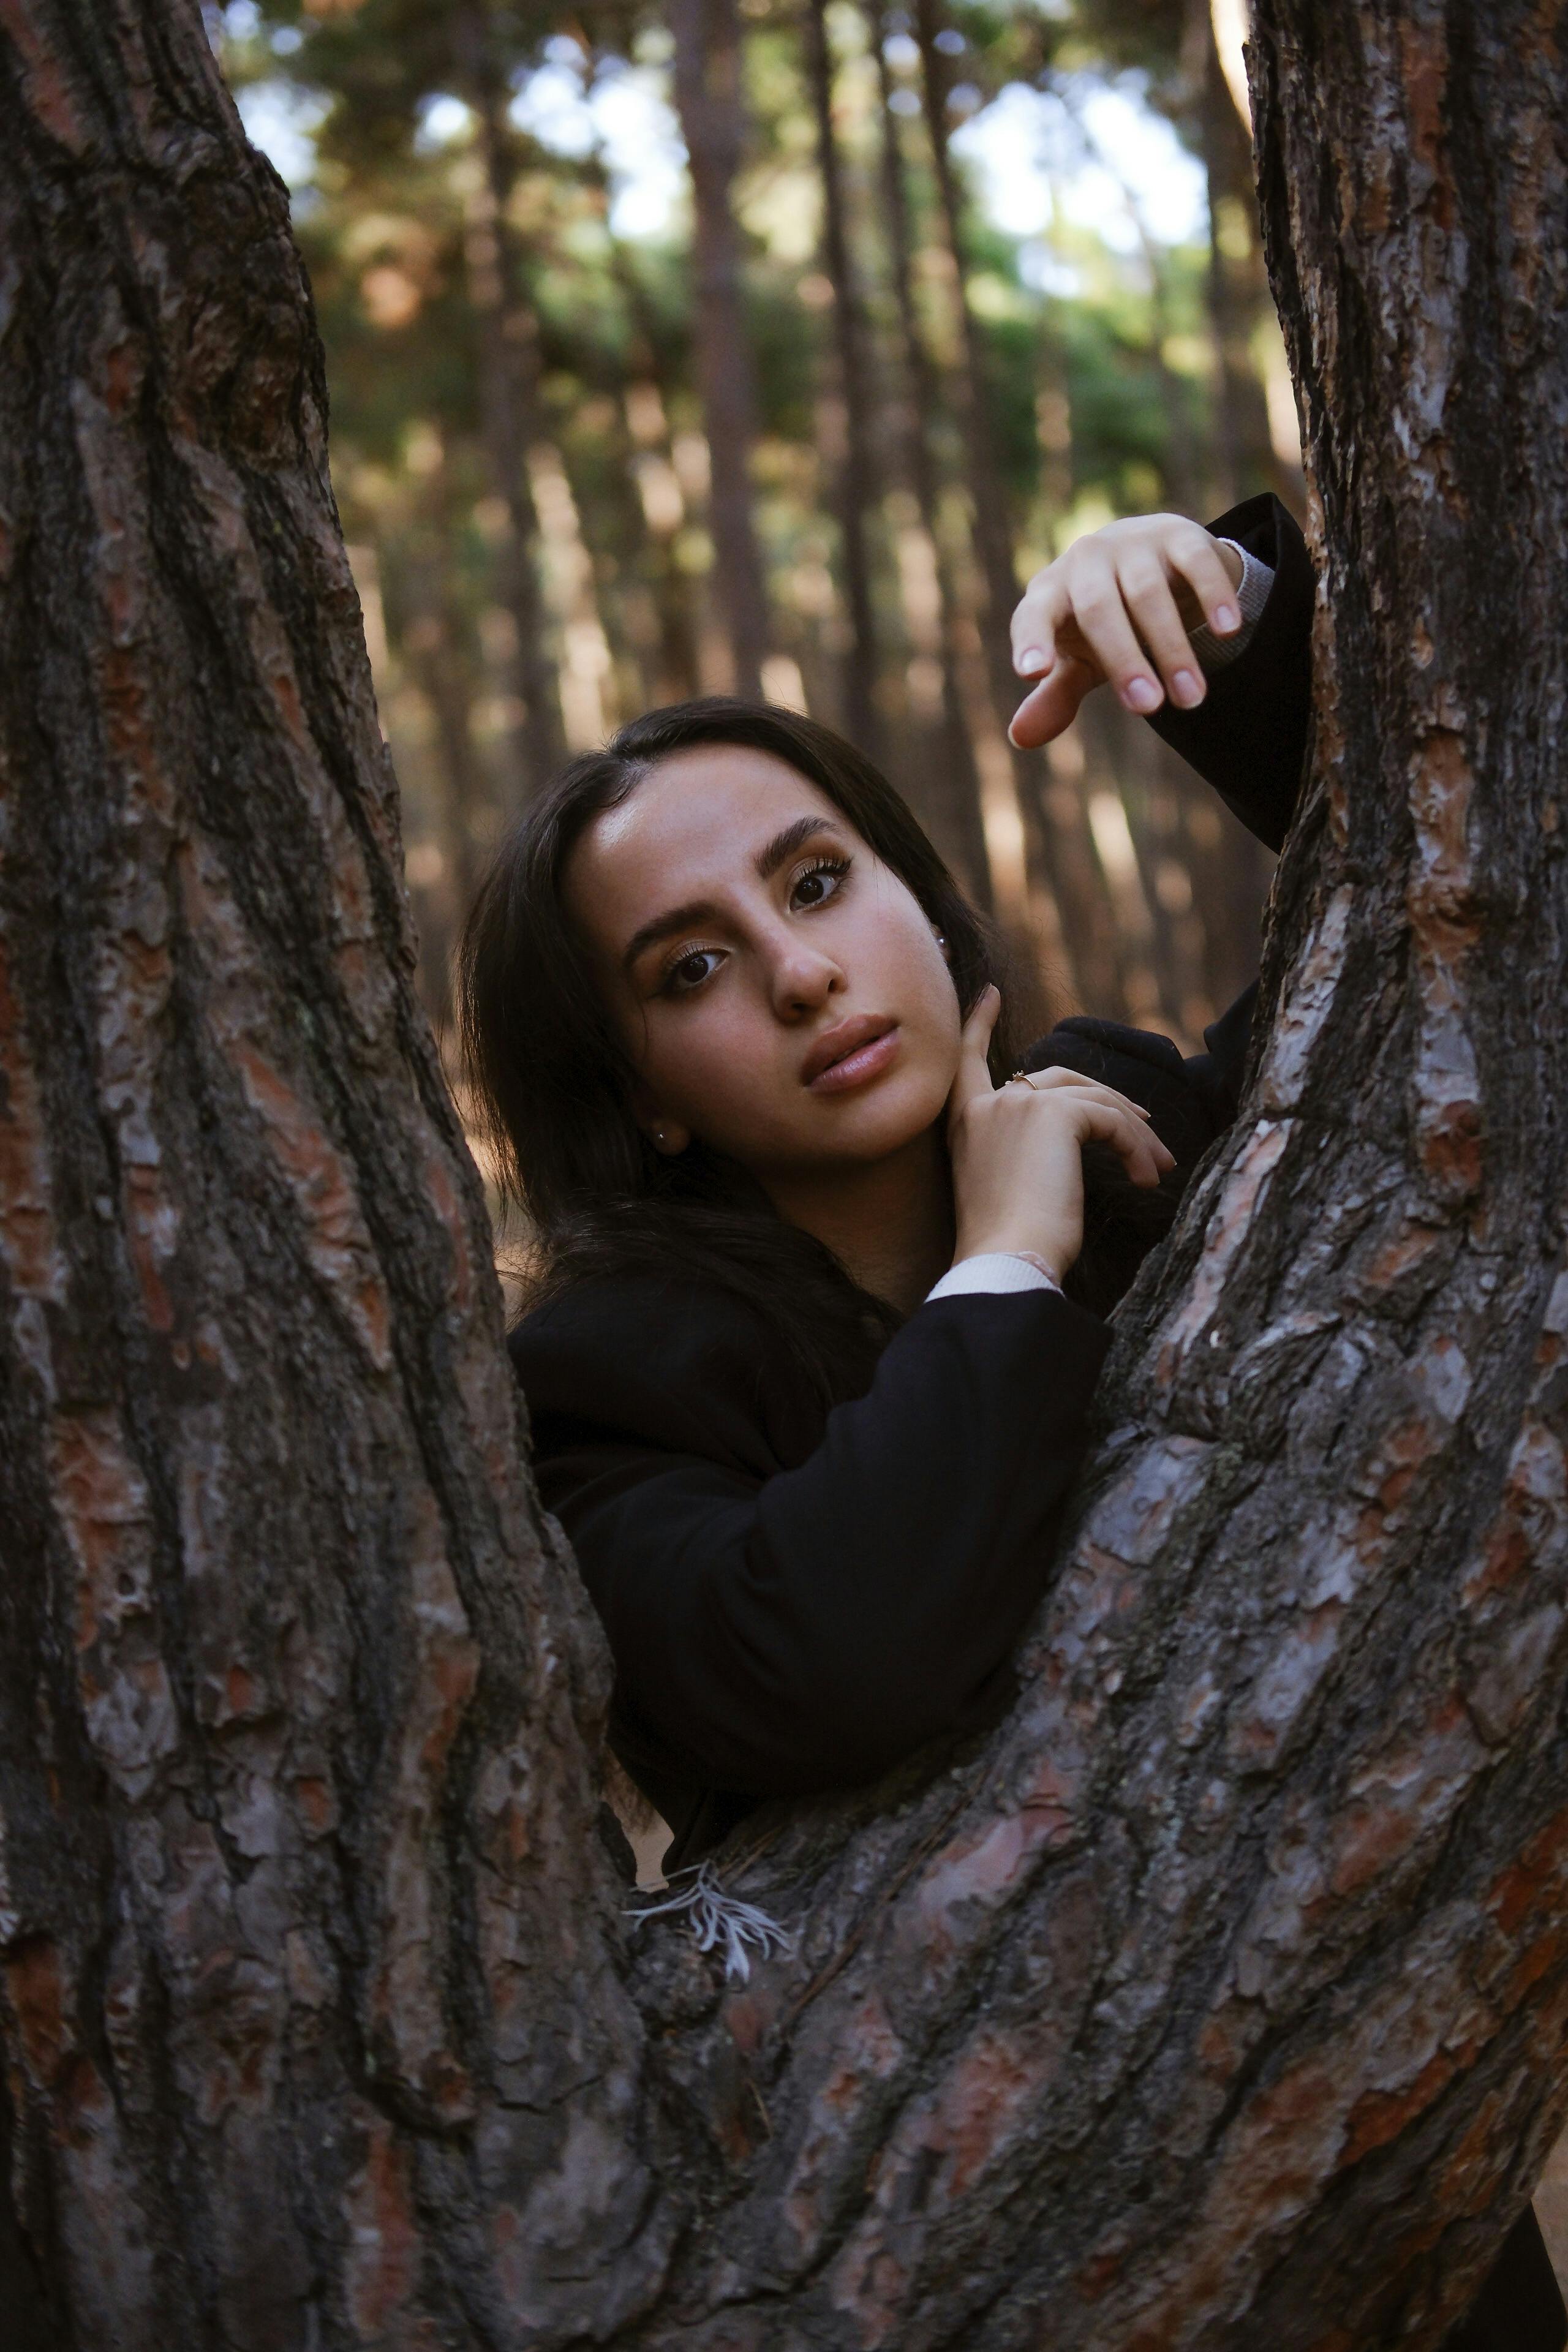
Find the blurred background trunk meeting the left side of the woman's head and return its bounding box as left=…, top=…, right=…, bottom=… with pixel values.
left=454, top=0, right=567, bottom=793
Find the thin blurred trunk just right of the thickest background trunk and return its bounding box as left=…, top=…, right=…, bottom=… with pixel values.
left=804, top=0, right=881, bottom=760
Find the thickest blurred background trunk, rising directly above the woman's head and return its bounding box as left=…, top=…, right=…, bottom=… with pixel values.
left=670, top=0, right=769, bottom=701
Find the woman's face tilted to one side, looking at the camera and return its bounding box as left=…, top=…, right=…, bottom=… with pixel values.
left=567, top=743, right=959, bottom=1183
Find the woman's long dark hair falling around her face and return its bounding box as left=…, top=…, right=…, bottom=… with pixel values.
left=458, top=696, right=1164, bottom=1402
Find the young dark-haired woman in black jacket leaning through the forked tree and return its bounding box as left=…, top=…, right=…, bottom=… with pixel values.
left=463, top=499, right=1566, bottom=2352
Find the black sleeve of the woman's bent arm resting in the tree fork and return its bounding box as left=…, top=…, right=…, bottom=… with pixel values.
left=513, top=1291, right=1110, bottom=1797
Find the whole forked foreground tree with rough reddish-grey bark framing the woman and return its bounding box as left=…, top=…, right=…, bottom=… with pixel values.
left=0, top=0, right=1568, bottom=2352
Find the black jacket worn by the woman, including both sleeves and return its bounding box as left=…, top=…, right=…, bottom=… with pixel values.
left=510, top=499, right=1568, bottom=2352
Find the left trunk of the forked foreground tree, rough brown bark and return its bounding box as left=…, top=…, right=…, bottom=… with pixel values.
left=0, top=13, right=649, bottom=2352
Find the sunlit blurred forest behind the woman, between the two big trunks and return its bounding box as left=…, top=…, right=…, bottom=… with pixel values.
left=209, top=0, right=1302, bottom=1105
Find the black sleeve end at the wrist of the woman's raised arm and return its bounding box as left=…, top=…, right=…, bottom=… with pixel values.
left=1150, top=492, right=1316, bottom=849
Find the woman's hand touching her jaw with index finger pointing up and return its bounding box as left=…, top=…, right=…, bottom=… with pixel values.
left=948, top=988, right=1175, bottom=1282
